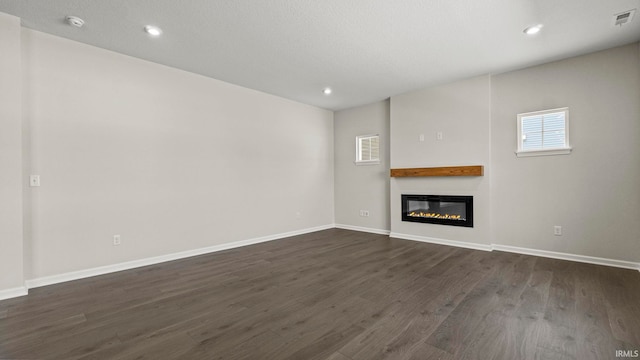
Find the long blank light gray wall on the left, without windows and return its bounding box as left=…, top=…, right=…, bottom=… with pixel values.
left=20, top=29, right=334, bottom=279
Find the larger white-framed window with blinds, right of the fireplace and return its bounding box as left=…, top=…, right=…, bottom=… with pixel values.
left=516, top=108, right=571, bottom=156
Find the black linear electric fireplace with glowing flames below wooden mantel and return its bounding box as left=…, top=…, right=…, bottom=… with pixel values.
left=402, top=194, right=473, bottom=227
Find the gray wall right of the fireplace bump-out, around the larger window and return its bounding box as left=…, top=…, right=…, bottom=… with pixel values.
left=491, top=43, right=640, bottom=261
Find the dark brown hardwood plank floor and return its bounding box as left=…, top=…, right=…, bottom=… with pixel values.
left=0, top=229, right=640, bottom=360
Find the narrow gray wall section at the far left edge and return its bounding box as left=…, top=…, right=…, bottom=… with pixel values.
left=0, top=13, right=24, bottom=297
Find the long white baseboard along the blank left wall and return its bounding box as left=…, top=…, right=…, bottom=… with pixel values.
left=23, top=224, right=335, bottom=296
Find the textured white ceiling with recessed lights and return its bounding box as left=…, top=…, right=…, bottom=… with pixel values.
left=0, top=0, right=640, bottom=110
